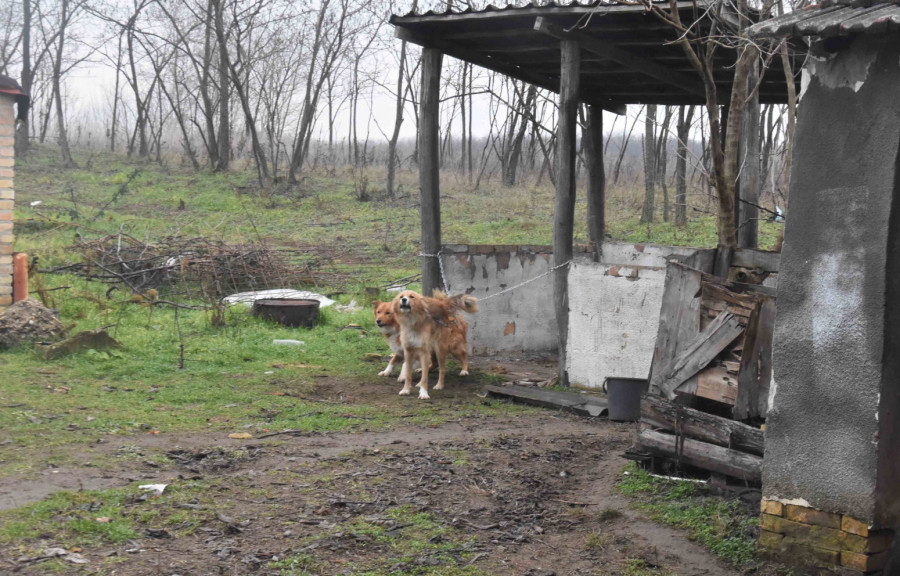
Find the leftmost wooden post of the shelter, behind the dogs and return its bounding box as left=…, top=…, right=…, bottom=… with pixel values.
left=419, top=48, right=443, bottom=296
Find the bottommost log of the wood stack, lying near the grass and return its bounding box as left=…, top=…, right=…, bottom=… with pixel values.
left=637, top=429, right=762, bottom=482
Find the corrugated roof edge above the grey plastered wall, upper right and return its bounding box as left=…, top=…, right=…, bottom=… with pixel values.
left=748, top=0, right=900, bottom=38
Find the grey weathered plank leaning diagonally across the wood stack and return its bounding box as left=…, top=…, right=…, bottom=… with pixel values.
left=657, top=312, right=744, bottom=400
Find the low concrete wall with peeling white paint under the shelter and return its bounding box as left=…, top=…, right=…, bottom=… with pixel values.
left=444, top=243, right=696, bottom=386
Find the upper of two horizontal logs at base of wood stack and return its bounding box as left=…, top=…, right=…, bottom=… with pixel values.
left=641, top=394, right=765, bottom=456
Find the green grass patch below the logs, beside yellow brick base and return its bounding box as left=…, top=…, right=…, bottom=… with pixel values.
left=617, top=464, right=758, bottom=567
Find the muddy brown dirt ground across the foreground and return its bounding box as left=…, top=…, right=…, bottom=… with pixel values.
left=0, top=365, right=736, bottom=576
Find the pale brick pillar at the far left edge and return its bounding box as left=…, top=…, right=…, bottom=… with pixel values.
left=0, top=92, right=16, bottom=312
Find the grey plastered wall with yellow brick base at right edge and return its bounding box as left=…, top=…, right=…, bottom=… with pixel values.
left=760, top=35, right=900, bottom=574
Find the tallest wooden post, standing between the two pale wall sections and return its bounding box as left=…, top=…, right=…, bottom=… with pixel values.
left=553, top=40, right=581, bottom=386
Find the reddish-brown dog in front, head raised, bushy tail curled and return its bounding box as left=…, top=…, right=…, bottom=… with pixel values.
left=391, top=290, right=478, bottom=399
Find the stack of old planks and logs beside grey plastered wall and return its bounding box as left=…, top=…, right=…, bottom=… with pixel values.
left=638, top=254, right=775, bottom=482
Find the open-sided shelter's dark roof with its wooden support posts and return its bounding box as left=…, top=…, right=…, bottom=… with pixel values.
left=390, top=0, right=802, bottom=385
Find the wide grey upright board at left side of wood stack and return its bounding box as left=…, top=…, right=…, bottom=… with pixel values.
left=650, top=262, right=703, bottom=394
